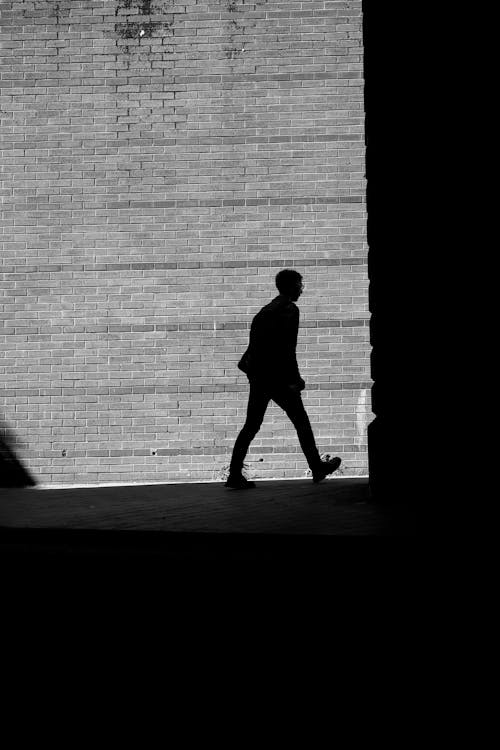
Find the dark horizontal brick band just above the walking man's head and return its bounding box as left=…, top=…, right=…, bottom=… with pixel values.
left=0, top=258, right=367, bottom=280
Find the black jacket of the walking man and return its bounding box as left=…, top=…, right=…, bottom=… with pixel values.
left=238, top=294, right=305, bottom=389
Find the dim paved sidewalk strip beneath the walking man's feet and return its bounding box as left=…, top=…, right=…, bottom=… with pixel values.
left=0, top=478, right=415, bottom=556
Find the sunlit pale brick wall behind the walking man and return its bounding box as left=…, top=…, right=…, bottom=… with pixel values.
left=0, top=0, right=371, bottom=484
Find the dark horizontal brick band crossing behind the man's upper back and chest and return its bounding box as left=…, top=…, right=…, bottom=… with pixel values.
left=0, top=318, right=370, bottom=336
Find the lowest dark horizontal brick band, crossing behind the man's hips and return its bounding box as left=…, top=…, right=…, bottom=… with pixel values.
left=0, top=381, right=373, bottom=398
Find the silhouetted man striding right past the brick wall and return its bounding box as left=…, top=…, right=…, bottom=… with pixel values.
left=226, top=269, right=341, bottom=489
